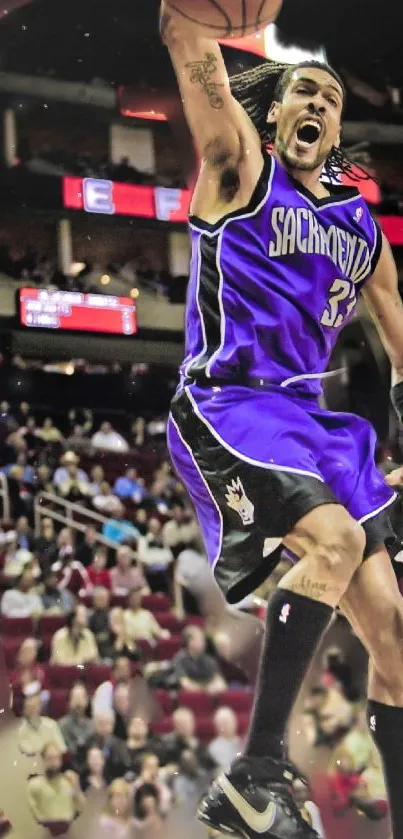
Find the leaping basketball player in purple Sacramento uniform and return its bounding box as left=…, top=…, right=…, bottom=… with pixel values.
left=161, top=7, right=403, bottom=839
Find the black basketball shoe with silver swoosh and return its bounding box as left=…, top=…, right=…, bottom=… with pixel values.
left=197, top=757, right=318, bottom=839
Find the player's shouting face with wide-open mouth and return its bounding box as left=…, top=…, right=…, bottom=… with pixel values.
left=268, top=67, right=343, bottom=171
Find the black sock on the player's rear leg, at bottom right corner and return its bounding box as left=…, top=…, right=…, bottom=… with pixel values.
left=367, top=699, right=403, bottom=839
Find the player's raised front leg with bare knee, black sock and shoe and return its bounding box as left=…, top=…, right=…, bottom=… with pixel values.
left=199, top=504, right=365, bottom=839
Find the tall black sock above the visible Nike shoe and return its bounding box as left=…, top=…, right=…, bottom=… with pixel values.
left=244, top=588, right=333, bottom=759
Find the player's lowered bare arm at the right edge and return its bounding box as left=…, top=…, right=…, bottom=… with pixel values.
left=363, top=236, right=403, bottom=383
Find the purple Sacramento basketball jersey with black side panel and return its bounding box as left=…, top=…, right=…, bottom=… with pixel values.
left=181, top=155, right=382, bottom=394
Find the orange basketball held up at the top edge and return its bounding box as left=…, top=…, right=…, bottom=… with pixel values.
left=167, top=0, right=283, bottom=38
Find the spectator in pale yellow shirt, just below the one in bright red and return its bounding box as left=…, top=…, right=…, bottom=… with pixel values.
left=51, top=604, right=98, bottom=665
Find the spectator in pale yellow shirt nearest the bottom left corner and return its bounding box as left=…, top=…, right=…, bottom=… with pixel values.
left=28, top=742, right=85, bottom=836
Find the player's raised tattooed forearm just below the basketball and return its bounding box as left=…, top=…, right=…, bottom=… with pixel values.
left=160, top=3, right=254, bottom=171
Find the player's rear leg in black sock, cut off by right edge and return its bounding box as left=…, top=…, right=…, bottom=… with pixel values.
left=341, top=547, right=403, bottom=839
